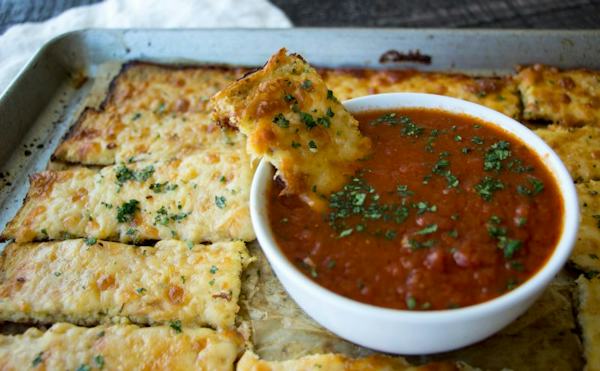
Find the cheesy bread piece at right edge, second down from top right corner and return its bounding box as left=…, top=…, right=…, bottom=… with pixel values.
left=534, top=125, right=600, bottom=182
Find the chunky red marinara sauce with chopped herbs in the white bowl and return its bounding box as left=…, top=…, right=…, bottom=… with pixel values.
left=269, top=109, right=563, bottom=310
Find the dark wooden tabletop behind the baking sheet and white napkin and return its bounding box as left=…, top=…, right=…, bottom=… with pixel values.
left=0, top=0, right=600, bottom=33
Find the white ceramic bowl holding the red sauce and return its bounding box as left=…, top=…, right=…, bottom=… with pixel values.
left=250, top=93, right=579, bottom=354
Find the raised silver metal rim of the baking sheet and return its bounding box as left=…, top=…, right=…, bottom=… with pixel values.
left=0, top=28, right=600, bottom=237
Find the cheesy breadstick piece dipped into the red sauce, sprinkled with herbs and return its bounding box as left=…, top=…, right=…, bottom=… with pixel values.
left=212, top=49, right=370, bottom=209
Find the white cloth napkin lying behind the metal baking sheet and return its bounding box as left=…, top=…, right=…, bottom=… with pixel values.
left=0, top=0, right=292, bottom=92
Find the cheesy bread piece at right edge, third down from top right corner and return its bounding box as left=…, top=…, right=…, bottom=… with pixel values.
left=570, top=181, right=600, bottom=272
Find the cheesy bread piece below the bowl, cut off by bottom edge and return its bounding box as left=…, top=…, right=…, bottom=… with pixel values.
left=237, top=351, right=471, bottom=371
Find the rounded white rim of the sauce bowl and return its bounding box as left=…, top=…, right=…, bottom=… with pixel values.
left=250, top=93, right=580, bottom=323
